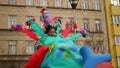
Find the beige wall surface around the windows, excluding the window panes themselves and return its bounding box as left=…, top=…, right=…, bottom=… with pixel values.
left=0, top=0, right=109, bottom=68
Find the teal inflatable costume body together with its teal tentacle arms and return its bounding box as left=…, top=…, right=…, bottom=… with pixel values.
left=31, top=23, right=83, bottom=68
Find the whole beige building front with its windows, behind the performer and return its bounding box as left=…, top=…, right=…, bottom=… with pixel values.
left=0, top=0, right=109, bottom=68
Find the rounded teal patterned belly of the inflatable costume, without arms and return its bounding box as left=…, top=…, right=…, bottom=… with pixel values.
left=40, top=36, right=83, bottom=68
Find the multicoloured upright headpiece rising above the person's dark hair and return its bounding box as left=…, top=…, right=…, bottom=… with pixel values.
left=40, top=8, right=62, bottom=31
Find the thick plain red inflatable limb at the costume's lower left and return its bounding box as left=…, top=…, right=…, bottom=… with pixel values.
left=25, top=45, right=48, bottom=68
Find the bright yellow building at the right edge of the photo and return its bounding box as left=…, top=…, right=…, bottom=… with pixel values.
left=105, top=0, right=120, bottom=68
